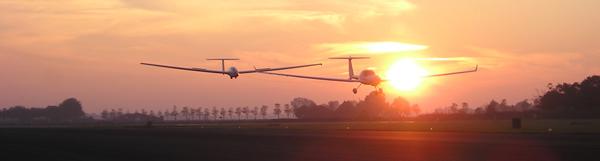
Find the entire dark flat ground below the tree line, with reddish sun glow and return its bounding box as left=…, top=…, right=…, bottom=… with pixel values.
left=0, top=120, right=600, bottom=161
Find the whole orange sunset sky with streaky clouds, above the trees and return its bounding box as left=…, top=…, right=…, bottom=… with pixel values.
left=0, top=0, right=600, bottom=112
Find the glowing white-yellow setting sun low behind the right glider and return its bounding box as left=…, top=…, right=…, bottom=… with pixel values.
left=386, top=59, right=429, bottom=91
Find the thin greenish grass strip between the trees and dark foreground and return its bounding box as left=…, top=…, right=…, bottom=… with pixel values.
left=148, top=120, right=600, bottom=134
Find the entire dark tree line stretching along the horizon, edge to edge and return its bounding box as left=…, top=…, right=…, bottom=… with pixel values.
left=0, top=75, right=600, bottom=123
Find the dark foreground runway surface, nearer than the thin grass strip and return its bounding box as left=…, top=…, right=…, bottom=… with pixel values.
left=0, top=127, right=600, bottom=161
